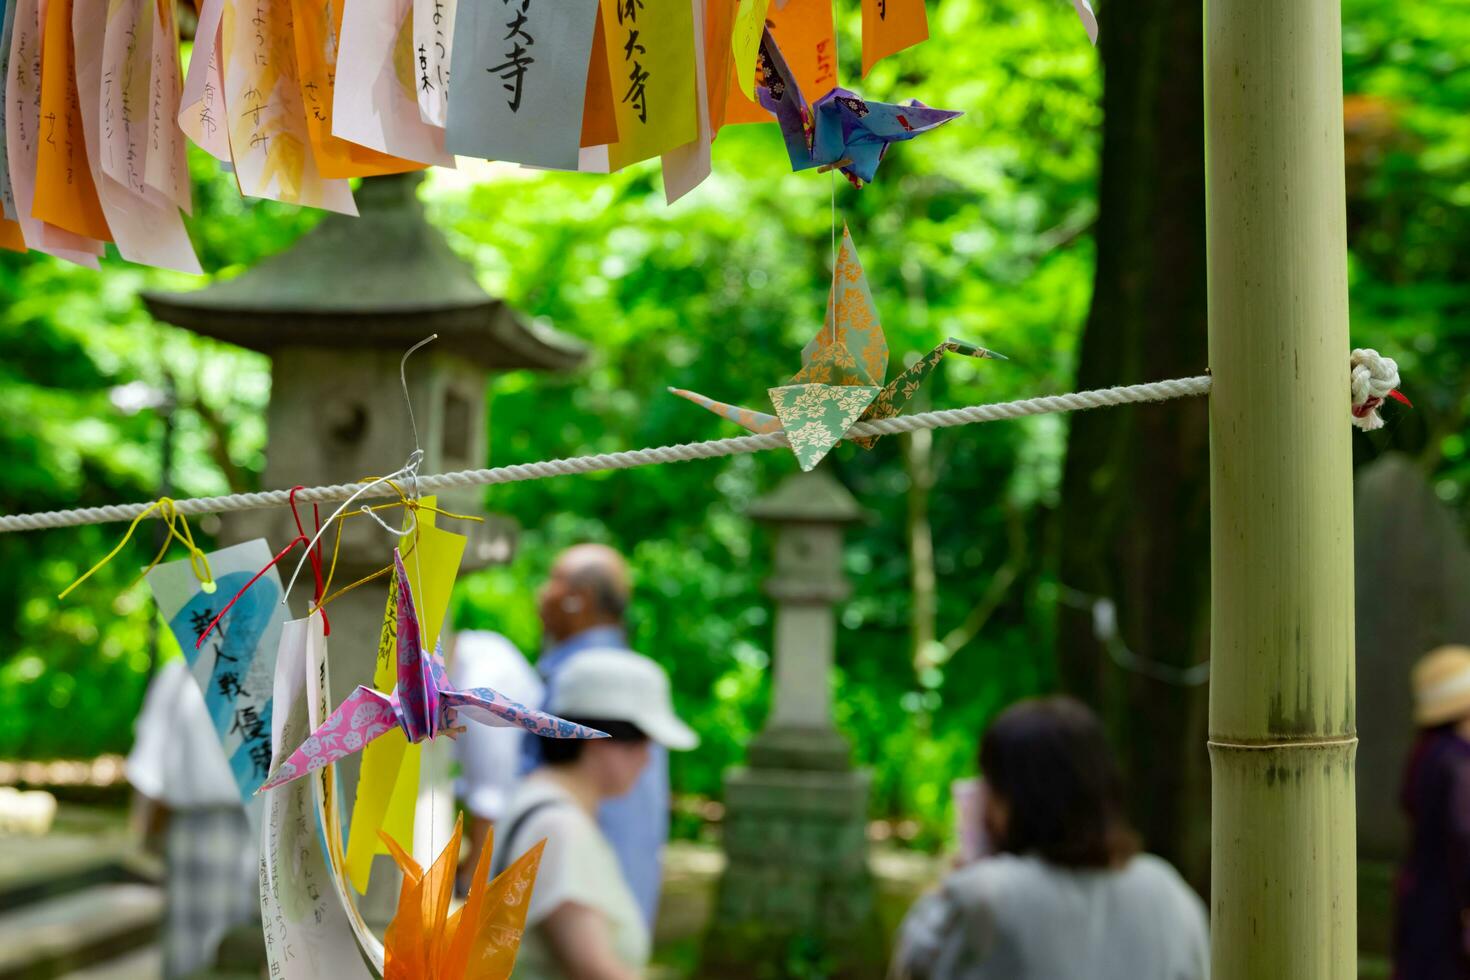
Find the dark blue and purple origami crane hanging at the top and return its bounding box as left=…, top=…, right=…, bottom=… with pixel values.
left=757, top=28, right=964, bottom=187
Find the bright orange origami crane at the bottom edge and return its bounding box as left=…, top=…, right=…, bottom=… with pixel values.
left=378, top=817, right=545, bottom=980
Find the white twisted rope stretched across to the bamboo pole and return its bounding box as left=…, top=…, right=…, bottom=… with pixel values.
left=0, top=375, right=1210, bottom=533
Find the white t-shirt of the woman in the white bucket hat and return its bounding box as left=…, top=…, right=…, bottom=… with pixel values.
left=495, top=773, right=651, bottom=980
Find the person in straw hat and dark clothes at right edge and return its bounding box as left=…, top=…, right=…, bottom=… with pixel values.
left=1394, top=646, right=1470, bottom=980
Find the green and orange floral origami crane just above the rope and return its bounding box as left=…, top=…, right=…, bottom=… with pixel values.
left=669, top=225, right=1005, bottom=470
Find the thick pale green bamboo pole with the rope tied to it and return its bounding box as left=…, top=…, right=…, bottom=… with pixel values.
left=1205, top=0, right=1357, bottom=980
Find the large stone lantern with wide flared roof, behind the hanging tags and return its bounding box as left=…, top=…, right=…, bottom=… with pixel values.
left=143, top=173, right=585, bottom=920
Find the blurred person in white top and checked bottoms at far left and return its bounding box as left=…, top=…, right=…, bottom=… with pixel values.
left=126, top=658, right=260, bottom=980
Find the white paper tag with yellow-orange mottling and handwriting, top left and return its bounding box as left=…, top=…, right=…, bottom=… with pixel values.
left=219, top=0, right=357, bottom=215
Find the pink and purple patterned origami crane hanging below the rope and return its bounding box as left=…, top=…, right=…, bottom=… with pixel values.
left=257, top=548, right=607, bottom=792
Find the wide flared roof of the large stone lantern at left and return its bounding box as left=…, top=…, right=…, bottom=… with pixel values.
left=143, top=173, right=587, bottom=372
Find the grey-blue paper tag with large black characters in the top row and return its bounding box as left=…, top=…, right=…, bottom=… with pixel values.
left=445, top=0, right=596, bottom=170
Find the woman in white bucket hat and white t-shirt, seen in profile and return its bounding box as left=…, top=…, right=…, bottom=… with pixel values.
left=492, top=649, right=700, bottom=980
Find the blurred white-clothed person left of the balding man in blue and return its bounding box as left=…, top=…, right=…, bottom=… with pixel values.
left=450, top=630, right=545, bottom=893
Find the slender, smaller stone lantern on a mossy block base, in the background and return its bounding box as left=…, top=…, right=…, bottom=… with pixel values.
left=700, top=470, right=883, bottom=977
